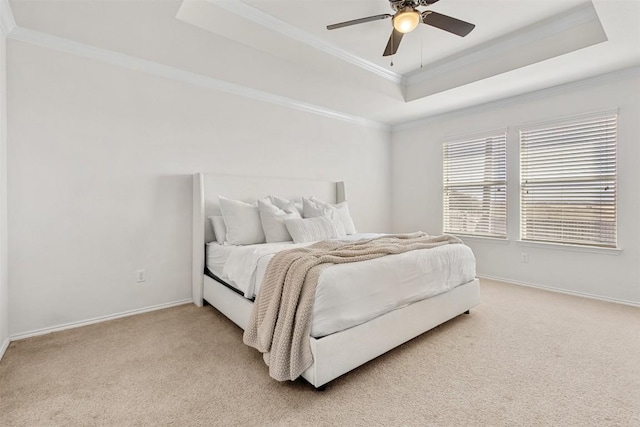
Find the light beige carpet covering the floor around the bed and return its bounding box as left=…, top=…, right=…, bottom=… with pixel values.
left=0, top=280, right=640, bottom=426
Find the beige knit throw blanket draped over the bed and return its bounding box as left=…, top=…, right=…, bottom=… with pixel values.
left=243, top=232, right=462, bottom=381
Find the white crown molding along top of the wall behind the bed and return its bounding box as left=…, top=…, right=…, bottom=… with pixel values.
left=8, top=27, right=391, bottom=131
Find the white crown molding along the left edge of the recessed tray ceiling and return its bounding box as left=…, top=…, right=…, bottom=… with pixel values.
left=206, top=0, right=403, bottom=84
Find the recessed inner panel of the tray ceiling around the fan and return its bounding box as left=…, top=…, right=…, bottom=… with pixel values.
left=240, top=0, right=585, bottom=75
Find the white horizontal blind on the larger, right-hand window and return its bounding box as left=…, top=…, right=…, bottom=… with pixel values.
left=520, top=114, right=617, bottom=247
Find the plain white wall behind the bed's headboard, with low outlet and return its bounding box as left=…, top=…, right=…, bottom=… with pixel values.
left=8, top=40, right=391, bottom=335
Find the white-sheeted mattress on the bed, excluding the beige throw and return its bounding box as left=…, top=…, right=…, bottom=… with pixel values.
left=207, top=234, right=476, bottom=338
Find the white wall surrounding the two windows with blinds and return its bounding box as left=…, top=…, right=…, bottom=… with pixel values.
left=391, top=68, right=640, bottom=304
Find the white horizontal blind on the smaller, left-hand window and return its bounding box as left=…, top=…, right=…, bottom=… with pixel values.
left=443, top=132, right=507, bottom=238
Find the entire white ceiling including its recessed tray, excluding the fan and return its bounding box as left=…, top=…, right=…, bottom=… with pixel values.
left=5, top=0, right=640, bottom=126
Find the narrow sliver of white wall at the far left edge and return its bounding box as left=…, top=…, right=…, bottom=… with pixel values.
left=0, top=30, right=9, bottom=358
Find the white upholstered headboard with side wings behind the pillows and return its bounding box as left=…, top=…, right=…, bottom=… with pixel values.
left=192, top=173, right=347, bottom=306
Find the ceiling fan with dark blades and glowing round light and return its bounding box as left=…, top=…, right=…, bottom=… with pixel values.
left=327, top=0, right=475, bottom=56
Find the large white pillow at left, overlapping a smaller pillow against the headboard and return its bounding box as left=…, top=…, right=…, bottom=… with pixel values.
left=218, top=196, right=265, bottom=245
